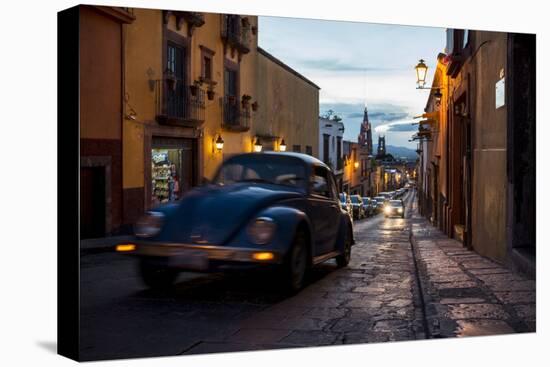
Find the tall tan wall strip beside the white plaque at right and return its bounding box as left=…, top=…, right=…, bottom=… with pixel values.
left=468, top=32, right=508, bottom=260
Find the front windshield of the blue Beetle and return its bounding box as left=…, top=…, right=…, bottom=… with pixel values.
left=213, top=154, right=306, bottom=190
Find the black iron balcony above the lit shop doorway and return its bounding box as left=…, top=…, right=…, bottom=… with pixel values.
left=155, top=79, right=206, bottom=127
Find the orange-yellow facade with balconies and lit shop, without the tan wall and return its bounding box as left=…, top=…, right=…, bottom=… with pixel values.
left=123, top=9, right=258, bottom=220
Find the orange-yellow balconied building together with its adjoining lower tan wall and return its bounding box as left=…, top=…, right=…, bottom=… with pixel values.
left=121, top=9, right=319, bottom=227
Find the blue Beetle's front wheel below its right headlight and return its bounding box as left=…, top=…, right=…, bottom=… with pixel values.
left=285, top=231, right=309, bottom=293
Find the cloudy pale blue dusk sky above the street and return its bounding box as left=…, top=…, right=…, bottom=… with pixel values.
left=258, top=17, right=445, bottom=148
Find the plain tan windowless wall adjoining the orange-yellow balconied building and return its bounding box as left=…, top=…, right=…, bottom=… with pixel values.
left=254, top=53, right=319, bottom=157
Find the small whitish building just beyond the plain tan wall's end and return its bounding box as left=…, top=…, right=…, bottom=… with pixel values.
left=319, top=117, right=344, bottom=186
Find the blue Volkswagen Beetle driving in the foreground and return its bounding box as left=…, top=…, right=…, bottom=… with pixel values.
left=117, top=152, right=354, bottom=291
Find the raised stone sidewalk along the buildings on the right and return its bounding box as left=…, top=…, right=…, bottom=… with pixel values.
left=411, top=212, right=536, bottom=338
